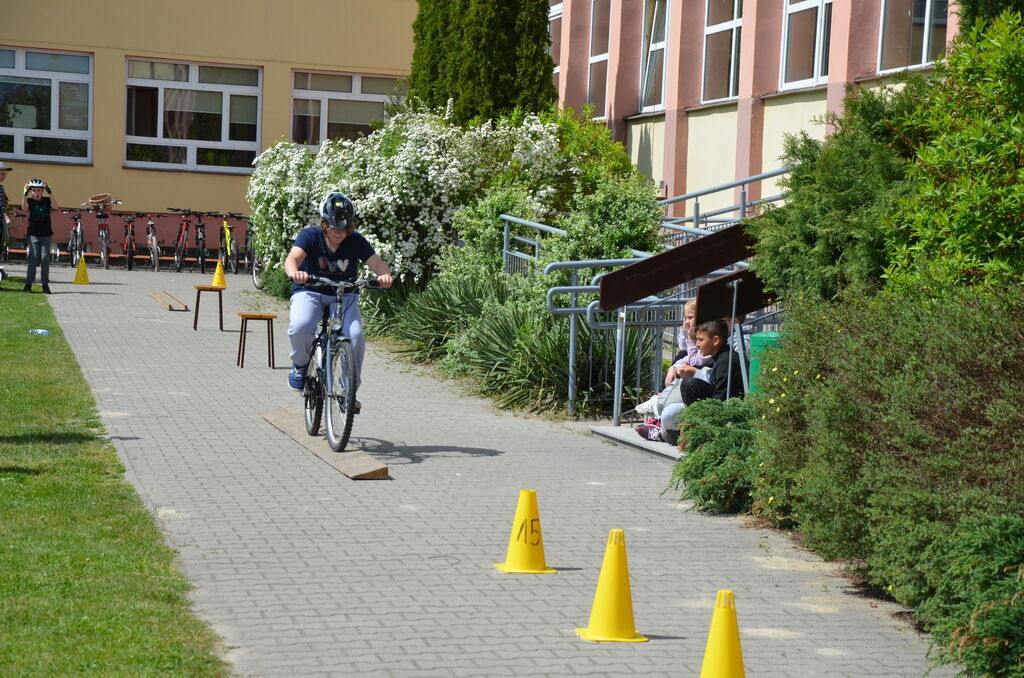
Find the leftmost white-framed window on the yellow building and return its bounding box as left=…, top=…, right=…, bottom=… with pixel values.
left=0, top=47, right=92, bottom=164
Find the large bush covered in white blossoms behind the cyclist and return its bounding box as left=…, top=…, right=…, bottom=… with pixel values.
left=248, top=109, right=572, bottom=280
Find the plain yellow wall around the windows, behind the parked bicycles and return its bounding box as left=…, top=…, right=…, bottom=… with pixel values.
left=0, top=0, right=417, bottom=213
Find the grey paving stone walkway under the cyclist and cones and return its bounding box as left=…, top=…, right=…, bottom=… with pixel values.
left=16, top=263, right=954, bottom=678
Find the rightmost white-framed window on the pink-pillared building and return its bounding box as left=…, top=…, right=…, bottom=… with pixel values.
left=879, top=0, right=947, bottom=71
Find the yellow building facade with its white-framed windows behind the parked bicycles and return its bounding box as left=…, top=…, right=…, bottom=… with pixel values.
left=0, top=0, right=417, bottom=231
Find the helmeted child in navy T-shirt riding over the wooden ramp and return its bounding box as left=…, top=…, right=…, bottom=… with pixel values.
left=285, top=193, right=392, bottom=391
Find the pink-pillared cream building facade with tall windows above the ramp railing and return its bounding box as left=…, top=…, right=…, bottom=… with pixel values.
left=550, top=0, right=957, bottom=216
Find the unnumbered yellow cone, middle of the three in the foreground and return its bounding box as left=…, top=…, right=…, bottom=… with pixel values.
left=577, top=529, right=647, bottom=643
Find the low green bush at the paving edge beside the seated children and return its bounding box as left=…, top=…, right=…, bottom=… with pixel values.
left=669, top=398, right=757, bottom=513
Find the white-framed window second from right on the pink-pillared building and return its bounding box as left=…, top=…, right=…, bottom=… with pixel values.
left=782, top=0, right=831, bottom=89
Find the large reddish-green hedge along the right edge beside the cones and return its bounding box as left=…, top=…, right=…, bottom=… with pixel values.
left=753, top=284, right=1024, bottom=676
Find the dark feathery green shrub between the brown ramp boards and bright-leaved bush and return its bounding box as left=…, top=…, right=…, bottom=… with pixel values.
left=746, top=76, right=928, bottom=300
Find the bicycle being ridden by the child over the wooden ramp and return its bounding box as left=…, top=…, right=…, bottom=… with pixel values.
left=302, top=276, right=379, bottom=452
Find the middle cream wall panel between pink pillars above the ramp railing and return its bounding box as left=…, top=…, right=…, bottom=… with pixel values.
left=686, top=105, right=736, bottom=215
